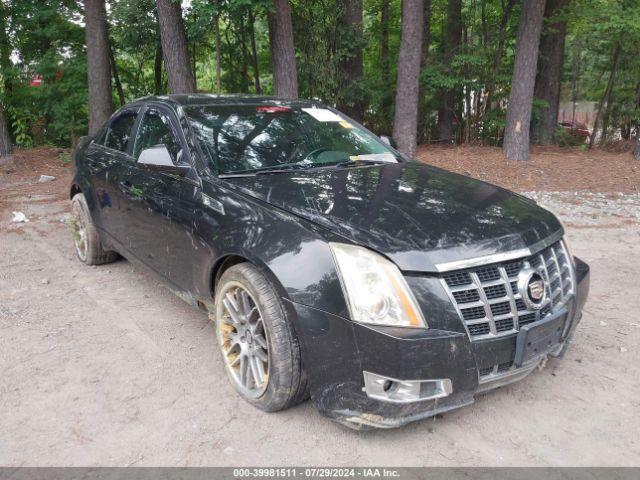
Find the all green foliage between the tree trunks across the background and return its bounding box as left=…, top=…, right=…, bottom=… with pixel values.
left=0, top=0, right=640, bottom=145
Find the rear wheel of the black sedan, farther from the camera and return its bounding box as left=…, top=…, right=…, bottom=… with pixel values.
left=71, top=193, right=118, bottom=265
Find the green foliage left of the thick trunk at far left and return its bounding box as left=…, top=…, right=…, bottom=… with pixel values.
left=3, top=0, right=87, bottom=146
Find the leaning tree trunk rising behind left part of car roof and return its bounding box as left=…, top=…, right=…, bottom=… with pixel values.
left=156, top=0, right=196, bottom=93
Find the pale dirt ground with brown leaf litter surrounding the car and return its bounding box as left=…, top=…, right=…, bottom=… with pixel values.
left=0, top=149, right=640, bottom=466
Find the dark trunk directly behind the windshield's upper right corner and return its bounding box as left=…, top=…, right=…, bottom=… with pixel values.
left=337, top=0, right=365, bottom=122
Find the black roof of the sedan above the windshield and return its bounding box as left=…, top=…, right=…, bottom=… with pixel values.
left=131, top=93, right=321, bottom=107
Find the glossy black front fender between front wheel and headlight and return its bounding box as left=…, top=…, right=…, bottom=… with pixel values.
left=194, top=180, right=348, bottom=317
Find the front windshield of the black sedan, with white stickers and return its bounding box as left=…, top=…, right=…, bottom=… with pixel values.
left=185, top=105, right=398, bottom=174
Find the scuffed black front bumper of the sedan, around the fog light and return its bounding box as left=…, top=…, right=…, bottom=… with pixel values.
left=289, top=259, right=589, bottom=429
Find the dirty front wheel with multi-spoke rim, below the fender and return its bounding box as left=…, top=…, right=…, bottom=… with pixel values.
left=215, top=263, right=309, bottom=412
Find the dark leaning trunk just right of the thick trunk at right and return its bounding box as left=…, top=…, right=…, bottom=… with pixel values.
left=531, top=0, right=569, bottom=145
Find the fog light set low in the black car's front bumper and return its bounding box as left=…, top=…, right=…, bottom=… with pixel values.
left=362, top=372, right=453, bottom=403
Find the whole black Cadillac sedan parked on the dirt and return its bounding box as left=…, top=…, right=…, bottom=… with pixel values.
left=70, top=95, right=589, bottom=428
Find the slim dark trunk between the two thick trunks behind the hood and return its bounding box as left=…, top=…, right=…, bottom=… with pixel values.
left=438, top=0, right=462, bottom=142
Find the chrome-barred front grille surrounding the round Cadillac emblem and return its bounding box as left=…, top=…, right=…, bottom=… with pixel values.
left=442, top=241, right=575, bottom=342
